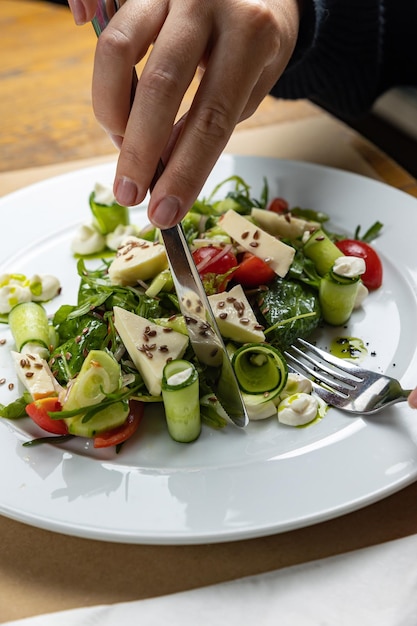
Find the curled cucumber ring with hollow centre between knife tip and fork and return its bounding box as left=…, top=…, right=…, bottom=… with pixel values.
left=232, top=343, right=288, bottom=400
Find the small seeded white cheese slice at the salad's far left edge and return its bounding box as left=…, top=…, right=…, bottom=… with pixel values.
left=11, top=351, right=62, bottom=400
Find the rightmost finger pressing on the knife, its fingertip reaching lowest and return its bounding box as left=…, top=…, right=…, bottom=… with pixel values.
left=145, top=2, right=298, bottom=228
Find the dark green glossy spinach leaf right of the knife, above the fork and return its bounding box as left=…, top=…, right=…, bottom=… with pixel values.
left=260, top=278, right=321, bottom=349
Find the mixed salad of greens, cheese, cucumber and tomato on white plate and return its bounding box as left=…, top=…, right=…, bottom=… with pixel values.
left=0, top=176, right=382, bottom=448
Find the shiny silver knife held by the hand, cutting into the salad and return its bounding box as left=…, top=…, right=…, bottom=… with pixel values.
left=92, top=0, right=249, bottom=427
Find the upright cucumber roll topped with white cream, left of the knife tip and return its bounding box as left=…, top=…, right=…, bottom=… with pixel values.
left=162, top=359, right=201, bottom=443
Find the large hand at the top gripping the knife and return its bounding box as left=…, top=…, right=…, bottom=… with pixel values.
left=69, top=0, right=301, bottom=228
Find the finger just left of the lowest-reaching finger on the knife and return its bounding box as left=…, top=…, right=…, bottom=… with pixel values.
left=113, top=3, right=210, bottom=204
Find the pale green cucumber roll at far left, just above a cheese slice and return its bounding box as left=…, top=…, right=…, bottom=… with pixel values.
left=9, top=302, right=50, bottom=352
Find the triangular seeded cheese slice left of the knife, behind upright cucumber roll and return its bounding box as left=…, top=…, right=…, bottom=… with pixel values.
left=114, top=307, right=188, bottom=396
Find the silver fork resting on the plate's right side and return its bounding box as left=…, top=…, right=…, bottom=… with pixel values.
left=284, top=339, right=411, bottom=414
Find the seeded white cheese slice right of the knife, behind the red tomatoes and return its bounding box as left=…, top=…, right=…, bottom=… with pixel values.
left=220, top=209, right=295, bottom=278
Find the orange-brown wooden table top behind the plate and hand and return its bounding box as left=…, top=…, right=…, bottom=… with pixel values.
left=0, top=0, right=417, bottom=195
